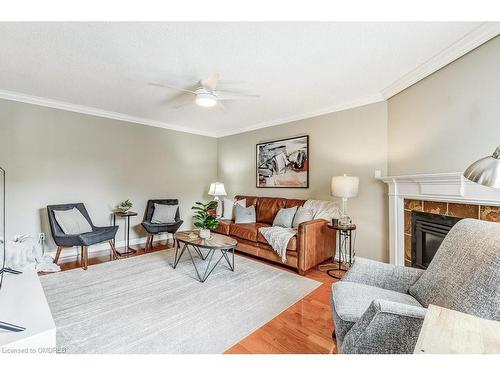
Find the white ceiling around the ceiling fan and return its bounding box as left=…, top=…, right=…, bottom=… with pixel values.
left=0, top=22, right=499, bottom=136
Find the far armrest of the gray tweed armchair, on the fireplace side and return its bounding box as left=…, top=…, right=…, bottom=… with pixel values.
left=342, top=257, right=424, bottom=293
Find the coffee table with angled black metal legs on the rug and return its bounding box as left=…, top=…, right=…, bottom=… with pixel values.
left=174, top=230, right=238, bottom=283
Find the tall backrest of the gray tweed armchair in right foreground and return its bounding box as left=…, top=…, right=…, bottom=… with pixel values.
left=409, top=219, right=500, bottom=320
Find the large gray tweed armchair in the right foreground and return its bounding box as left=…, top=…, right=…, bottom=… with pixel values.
left=332, top=219, right=500, bottom=353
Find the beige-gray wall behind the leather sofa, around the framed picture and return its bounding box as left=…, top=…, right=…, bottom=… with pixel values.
left=218, top=102, right=388, bottom=261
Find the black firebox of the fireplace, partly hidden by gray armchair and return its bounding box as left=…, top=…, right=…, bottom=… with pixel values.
left=411, top=211, right=462, bottom=269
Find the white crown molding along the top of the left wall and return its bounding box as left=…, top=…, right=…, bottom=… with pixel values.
left=0, top=90, right=216, bottom=137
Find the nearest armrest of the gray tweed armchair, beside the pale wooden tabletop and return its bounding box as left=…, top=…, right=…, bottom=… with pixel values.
left=340, top=299, right=427, bottom=354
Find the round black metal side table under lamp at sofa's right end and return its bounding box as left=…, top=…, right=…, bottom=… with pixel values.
left=319, top=224, right=356, bottom=279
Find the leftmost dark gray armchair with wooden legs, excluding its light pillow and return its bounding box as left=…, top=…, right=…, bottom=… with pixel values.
left=47, top=203, right=118, bottom=270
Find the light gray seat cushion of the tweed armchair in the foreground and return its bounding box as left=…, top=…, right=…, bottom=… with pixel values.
left=332, top=281, right=422, bottom=323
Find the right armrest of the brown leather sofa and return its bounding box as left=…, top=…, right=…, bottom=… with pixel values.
left=297, top=219, right=335, bottom=273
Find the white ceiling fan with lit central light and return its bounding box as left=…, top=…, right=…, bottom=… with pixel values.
left=149, top=73, right=259, bottom=108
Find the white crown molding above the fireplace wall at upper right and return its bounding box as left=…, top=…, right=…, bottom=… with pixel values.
left=381, top=22, right=500, bottom=99
